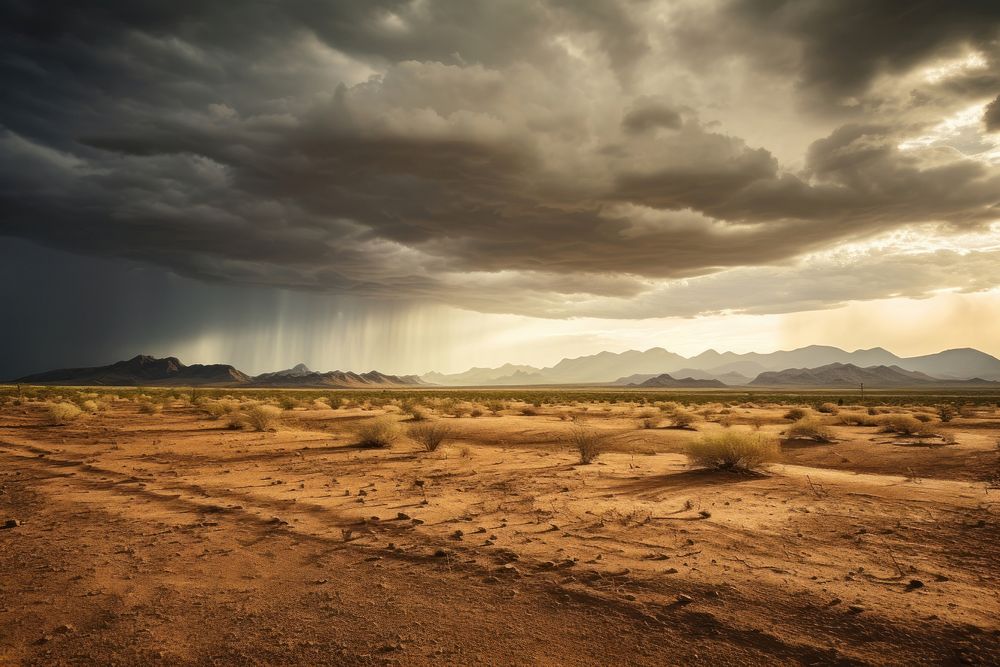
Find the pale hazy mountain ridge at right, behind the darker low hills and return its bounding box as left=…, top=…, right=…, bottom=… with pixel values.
left=423, top=345, right=1000, bottom=385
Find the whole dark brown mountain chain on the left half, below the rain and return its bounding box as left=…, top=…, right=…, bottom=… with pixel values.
left=14, top=354, right=425, bottom=388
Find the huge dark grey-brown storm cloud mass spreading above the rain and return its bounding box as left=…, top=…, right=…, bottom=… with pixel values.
left=0, top=0, right=1000, bottom=316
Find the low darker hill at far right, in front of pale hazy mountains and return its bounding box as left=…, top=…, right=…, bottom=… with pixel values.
left=750, top=363, right=1000, bottom=388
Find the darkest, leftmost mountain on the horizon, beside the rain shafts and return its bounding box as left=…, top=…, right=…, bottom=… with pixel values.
left=15, top=354, right=250, bottom=386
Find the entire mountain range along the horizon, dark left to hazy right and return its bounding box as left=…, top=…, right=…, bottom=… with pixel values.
left=14, top=345, right=1000, bottom=388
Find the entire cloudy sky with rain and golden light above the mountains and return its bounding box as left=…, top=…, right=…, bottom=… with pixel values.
left=0, top=0, right=1000, bottom=377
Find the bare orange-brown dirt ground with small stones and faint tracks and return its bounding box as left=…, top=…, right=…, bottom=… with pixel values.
left=0, top=401, right=1000, bottom=665
